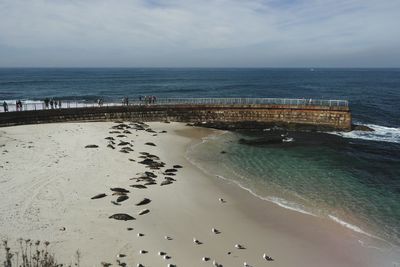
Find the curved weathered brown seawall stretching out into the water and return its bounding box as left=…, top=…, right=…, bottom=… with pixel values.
left=0, top=104, right=351, bottom=131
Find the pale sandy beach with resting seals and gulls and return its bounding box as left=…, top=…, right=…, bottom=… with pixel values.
left=0, top=122, right=395, bottom=267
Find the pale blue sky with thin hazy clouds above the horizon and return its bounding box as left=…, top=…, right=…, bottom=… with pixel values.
left=0, top=0, right=400, bottom=67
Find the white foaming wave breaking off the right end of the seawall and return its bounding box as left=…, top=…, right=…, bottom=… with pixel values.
left=329, top=124, right=400, bottom=144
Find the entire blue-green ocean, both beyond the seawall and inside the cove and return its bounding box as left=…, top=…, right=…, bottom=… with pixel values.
left=0, top=68, right=400, bottom=249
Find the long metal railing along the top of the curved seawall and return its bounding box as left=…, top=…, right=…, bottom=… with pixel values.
left=0, top=98, right=349, bottom=112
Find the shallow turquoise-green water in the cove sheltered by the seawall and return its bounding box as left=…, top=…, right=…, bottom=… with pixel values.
left=187, top=132, right=400, bottom=247
